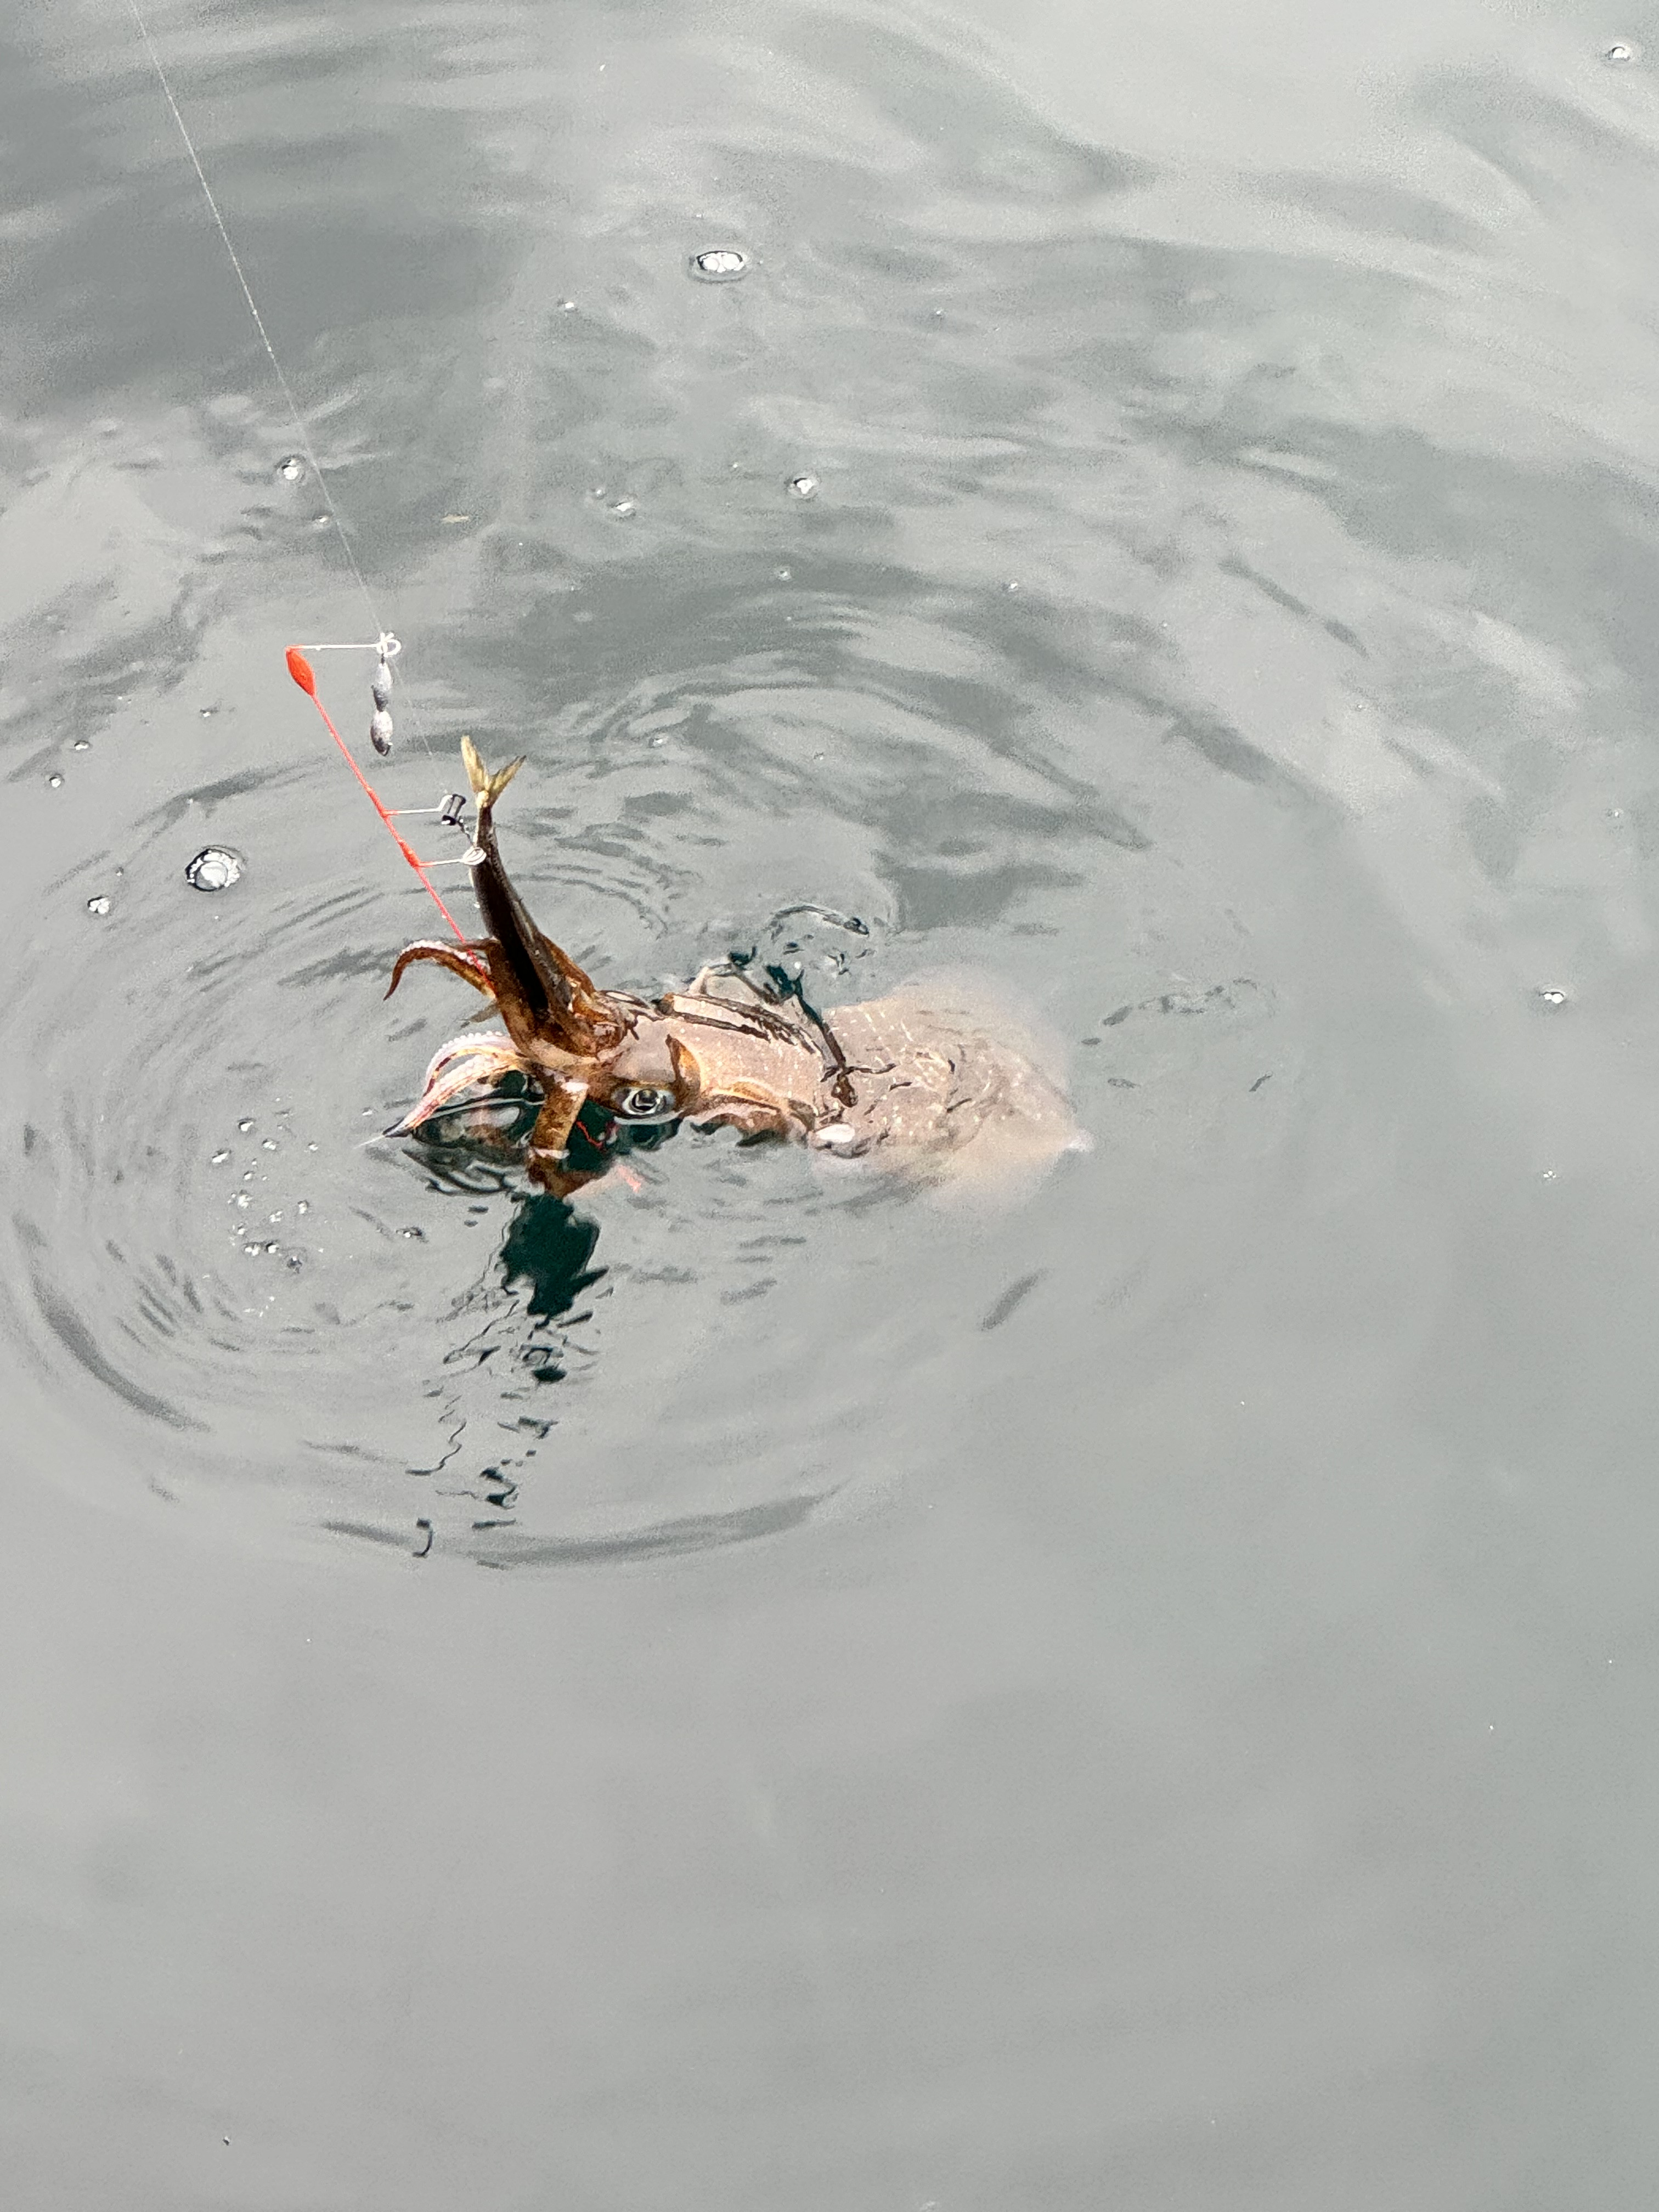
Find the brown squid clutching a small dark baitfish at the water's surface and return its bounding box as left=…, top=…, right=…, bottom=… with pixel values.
left=387, top=739, right=1082, bottom=1194
